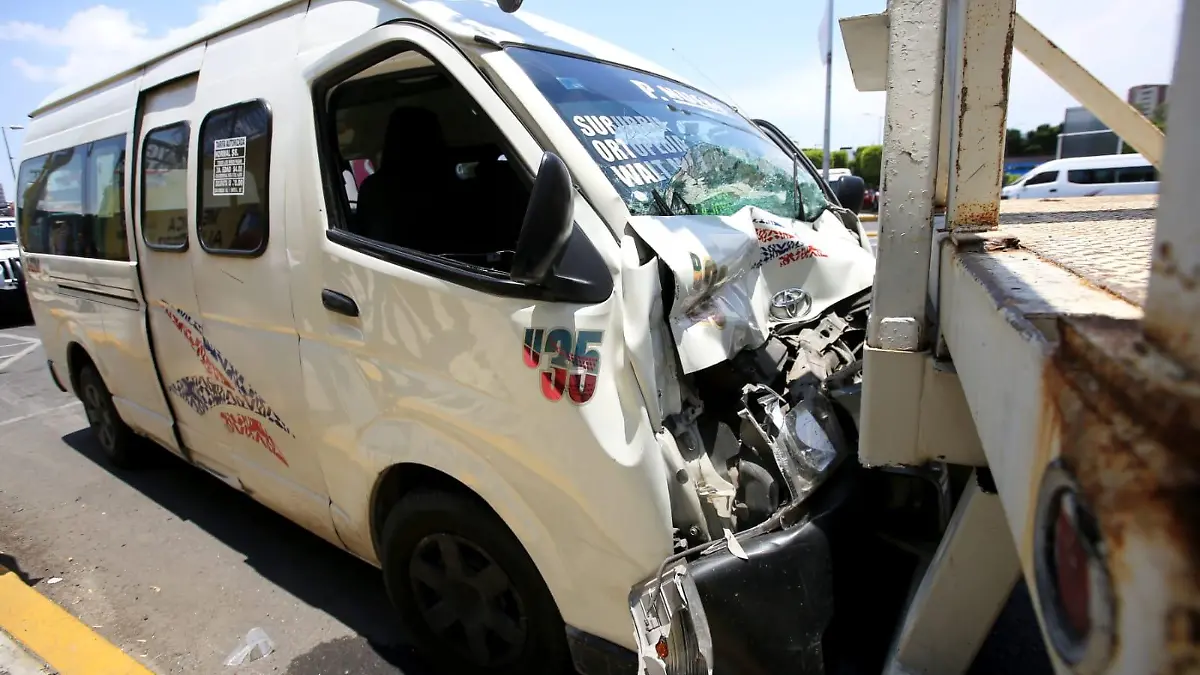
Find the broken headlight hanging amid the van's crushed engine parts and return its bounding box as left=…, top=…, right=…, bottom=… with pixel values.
left=739, top=384, right=851, bottom=503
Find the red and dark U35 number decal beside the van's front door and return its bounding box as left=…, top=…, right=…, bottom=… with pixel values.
left=524, top=328, right=604, bottom=405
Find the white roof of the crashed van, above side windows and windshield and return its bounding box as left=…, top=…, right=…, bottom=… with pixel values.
left=29, top=0, right=688, bottom=118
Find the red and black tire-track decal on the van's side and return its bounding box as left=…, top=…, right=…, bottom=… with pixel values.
left=160, top=300, right=294, bottom=466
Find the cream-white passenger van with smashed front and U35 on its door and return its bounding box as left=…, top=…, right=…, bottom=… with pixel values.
left=18, top=0, right=948, bottom=675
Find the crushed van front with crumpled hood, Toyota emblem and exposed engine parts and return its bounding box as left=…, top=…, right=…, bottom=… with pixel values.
left=626, top=200, right=875, bottom=549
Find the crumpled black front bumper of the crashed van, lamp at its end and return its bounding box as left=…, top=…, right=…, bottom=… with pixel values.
left=631, top=466, right=913, bottom=675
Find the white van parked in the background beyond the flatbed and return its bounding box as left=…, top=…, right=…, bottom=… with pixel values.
left=1000, top=155, right=1158, bottom=199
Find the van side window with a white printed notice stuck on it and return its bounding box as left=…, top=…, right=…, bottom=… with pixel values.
left=197, top=101, right=271, bottom=256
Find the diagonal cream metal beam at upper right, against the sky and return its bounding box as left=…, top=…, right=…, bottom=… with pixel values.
left=1013, top=16, right=1161, bottom=168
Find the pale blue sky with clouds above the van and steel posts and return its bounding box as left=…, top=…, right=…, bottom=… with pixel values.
left=0, top=0, right=1184, bottom=198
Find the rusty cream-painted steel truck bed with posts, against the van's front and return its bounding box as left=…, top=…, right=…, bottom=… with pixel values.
left=841, top=0, right=1200, bottom=673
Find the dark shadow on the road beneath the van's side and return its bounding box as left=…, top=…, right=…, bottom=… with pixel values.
left=60, top=429, right=431, bottom=675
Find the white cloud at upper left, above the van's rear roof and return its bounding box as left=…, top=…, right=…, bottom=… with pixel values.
left=0, top=0, right=280, bottom=85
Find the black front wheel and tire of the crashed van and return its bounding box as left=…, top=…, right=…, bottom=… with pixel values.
left=382, top=490, right=570, bottom=675
